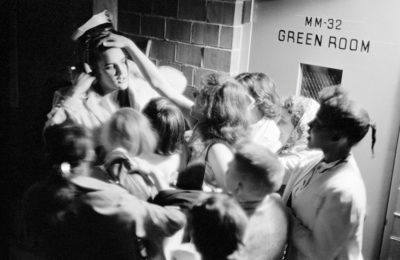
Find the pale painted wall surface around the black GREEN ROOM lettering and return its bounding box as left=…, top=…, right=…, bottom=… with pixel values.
left=249, top=0, right=400, bottom=259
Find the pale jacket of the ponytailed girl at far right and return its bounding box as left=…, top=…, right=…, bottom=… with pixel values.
left=283, top=155, right=366, bottom=260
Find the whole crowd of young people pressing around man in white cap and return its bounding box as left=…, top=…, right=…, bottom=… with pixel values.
left=24, top=13, right=375, bottom=260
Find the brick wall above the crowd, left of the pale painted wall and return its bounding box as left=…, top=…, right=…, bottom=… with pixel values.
left=118, top=0, right=252, bottom=93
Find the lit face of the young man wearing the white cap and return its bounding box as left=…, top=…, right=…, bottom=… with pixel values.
left=97, top=48, right=129, bottom=93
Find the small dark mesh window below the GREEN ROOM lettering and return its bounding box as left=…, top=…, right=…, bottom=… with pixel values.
left=300, top=63, right=343, bottom=101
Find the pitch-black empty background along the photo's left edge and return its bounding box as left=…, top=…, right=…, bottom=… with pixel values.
left=4, top=0, right=92, bottom=259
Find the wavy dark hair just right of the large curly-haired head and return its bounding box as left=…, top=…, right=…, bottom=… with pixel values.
left=235, top=72, right=280, bottom=119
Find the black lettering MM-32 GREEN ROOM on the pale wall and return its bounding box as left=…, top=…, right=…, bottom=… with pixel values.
left=278, top=16, right=371, bottom=53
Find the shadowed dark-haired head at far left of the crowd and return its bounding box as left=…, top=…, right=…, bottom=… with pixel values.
left=44, top=123, right=93, bottom=166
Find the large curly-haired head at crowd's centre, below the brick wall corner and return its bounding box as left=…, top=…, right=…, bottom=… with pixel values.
left=197, top=73, right=250, bottom=143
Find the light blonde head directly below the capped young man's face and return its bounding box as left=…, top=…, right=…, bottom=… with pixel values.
left=101, top=108, right=157, bottom=156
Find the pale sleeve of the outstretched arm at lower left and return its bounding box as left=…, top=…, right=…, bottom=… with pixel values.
left=82, top=189, right=186, bottom=238
